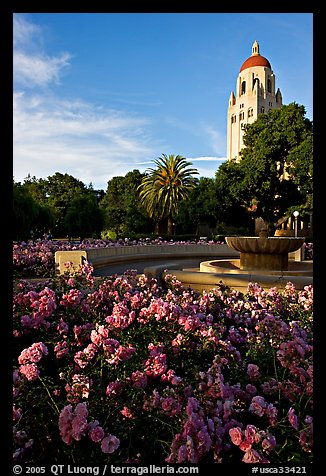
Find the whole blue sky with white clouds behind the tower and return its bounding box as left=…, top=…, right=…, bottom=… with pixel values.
left=13, top=13, right=313, bottom=190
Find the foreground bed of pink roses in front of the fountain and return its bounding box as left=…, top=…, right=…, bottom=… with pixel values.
left=13, top=263, right=313, bottom=465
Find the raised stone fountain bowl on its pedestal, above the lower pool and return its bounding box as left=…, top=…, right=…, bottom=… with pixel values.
left=225, top=236, right=305, bottom=271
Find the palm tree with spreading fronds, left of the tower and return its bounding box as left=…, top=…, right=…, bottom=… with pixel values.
left=138, top=154, right=198, bottom=234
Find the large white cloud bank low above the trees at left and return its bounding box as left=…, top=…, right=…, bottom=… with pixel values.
left=13, top=92, right=160, bottom=189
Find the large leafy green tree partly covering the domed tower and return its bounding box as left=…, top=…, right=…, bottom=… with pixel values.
left=217, top=103, right=313, bottom=232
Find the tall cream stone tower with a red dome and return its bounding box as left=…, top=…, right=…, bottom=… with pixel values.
left=227, top=41, right=282, bottom=162
